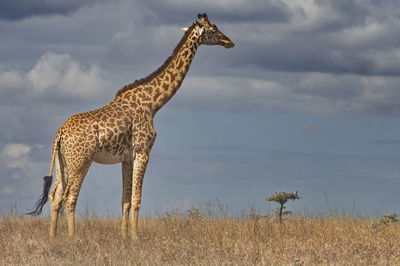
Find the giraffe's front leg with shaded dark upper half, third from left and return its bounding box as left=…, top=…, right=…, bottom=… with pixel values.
left=121, top=162, right=133, bottom=237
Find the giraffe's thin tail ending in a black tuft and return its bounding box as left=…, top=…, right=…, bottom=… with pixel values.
left=27, top=132, right=61, bottom=216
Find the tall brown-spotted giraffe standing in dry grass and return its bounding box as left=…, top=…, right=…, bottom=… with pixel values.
left=29, top=14, right=234, bottom=240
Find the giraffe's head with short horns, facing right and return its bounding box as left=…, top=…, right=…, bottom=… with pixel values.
left=197, top=13, right=235, bottom=48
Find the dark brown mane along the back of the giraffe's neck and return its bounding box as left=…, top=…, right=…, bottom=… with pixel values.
left=115, top=22, right=198, bottom=97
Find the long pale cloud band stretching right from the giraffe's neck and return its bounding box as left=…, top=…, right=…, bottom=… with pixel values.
left=171, top=72, right=400, bottom=116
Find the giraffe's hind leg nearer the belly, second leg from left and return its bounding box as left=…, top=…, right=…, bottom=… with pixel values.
left=64, top=163, right=90, bottom=237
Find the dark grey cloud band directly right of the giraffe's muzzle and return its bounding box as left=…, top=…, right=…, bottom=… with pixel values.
left=241, top=38, right=400, bottom=76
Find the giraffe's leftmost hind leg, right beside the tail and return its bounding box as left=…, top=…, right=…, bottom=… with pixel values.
left=49, top=155, right=65, bottom=237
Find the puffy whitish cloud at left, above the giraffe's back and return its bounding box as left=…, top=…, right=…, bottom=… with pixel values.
left=0, top=52, right=112, bottom=102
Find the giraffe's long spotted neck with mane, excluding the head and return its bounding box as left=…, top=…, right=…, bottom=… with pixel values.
left=116, top=24, right=202, bottom=116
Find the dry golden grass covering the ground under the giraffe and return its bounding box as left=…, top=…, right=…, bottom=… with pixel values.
left=0, top=215, right=400, bottom=265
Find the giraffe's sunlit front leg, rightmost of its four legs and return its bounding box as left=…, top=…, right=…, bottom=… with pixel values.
left=131, top=153, right=149, bottom=240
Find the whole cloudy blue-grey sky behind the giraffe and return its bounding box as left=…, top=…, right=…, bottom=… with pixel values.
left=0, top=0, right=400, bottom=216
